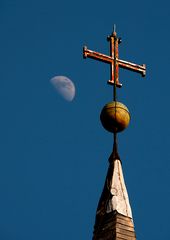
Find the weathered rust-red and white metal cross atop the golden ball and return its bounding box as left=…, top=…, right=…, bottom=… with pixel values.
left=83, top=26, right=146, bottom=87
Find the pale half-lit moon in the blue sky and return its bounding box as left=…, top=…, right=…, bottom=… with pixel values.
left=50, top=76, right=76, bottom=102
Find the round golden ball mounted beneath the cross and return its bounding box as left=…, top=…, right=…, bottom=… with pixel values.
left=100, top=102, right=130, bottom=133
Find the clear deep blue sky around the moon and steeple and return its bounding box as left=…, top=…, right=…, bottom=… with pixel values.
left=0, top=0, right=170, bottom=240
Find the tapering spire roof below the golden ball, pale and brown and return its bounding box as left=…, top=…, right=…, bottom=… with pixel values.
left=93, top=150, right=136, bottom=240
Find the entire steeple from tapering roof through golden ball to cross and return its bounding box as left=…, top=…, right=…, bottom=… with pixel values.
left=83, top=26, right=146, bottom=240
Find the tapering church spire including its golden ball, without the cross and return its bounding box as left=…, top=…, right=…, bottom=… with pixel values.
left=93, top=102, right=136, bottom=240
